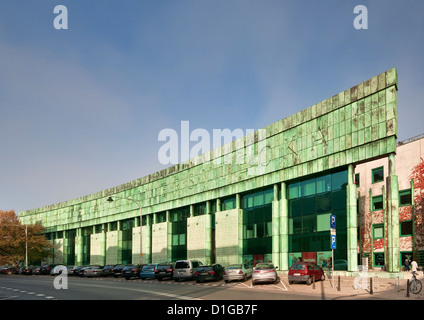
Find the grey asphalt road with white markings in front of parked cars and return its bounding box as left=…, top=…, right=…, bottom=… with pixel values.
left=0, top=275, right=320, bottom=301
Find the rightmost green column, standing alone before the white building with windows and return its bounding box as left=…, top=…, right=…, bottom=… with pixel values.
left=386, top=153, right=400, bottom=272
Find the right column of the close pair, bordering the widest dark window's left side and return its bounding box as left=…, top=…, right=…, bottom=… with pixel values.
left=278, top=182, right=289, bottom=271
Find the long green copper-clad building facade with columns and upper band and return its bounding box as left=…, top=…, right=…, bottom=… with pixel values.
left=19, top=69, right=399, bottom=271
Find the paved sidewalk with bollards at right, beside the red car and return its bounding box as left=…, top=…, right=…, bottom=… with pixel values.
left=280, top=272, right=424, bottom=300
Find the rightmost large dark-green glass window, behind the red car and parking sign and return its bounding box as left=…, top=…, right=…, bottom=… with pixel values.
left=287, top=170, right=347, bottom=269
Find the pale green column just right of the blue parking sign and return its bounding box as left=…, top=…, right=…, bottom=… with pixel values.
left=348, top=164, right=358, bottom=271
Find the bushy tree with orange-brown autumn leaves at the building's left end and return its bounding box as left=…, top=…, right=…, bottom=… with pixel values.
left=0, top=210, right=53, bottom=267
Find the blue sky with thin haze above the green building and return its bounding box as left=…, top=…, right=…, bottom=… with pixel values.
left=0, top=0, right=424, bottom=212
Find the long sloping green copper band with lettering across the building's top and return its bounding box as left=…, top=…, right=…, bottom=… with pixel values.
left=19, top=69, right=398, bottom=231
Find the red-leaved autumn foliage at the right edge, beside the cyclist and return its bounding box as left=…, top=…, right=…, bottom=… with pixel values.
left=409, top=158, right=424, bottom=256
